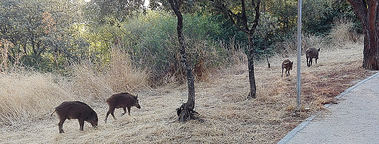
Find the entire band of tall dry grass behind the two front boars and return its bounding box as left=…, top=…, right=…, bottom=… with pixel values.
left=0, top=50, right=148, bottom=125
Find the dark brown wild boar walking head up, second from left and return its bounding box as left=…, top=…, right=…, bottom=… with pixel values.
left=105, top=93, right=141, bottom=123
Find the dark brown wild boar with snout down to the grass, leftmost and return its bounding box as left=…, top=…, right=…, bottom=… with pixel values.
left=51, top=101, right=98, bottom=133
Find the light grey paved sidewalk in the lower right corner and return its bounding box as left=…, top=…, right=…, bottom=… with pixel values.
left=279, top=73, right=379, bottom=144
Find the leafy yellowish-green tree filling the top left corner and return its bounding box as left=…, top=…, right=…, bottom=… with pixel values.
left=0, top=0, right=80, bottom=69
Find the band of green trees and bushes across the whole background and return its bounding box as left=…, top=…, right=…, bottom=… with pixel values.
left=0, top=0, right=360, bottom=82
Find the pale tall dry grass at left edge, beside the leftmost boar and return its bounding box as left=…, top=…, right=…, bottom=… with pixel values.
left=0, top=70, right=71, bottom=125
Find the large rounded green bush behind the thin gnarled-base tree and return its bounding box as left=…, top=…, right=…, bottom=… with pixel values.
left=122, top=11, right=232, bottom=82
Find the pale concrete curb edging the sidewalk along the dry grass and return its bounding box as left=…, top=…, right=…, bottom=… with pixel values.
left=277, top=72, right=379, bottom=144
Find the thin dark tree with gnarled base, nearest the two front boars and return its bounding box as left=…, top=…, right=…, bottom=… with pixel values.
left=168, top=0, right=196, bottom=122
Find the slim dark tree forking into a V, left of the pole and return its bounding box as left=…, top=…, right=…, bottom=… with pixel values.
left=214, top=0, right=261, bottom=98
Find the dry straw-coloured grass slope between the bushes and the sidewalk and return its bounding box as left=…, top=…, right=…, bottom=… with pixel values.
left=0, top=41, right=370, bottom=143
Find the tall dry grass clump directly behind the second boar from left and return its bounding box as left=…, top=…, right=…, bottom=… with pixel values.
left=65, top=49, right=149, bottom=102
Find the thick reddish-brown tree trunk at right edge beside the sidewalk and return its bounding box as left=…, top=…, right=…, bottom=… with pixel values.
left=348, top=0, right=379, bottom=70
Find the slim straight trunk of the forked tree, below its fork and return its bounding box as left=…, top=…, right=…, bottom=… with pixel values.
left=247, top=34, right=257, bottom=98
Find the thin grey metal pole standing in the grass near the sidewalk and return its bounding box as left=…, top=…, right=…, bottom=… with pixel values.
left=296, top=0, right=303, bottom=110
